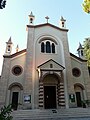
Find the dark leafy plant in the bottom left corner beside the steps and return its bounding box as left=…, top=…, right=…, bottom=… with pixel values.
left=0, top=105, right=13, bottom=120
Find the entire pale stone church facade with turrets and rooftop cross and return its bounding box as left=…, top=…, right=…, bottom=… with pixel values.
left=0, top=12, right=90, bottom=109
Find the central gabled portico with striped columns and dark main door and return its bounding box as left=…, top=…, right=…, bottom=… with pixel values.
left=38, top=59, right=65, bottom=109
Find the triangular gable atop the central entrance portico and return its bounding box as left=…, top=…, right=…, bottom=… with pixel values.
left=38, top=59, right=65, bottom=70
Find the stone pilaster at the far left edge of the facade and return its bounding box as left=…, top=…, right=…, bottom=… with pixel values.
left=0, top=57, right=10, bottom=107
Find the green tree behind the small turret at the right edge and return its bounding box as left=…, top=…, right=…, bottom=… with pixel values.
left=83, top=38, right=90, bottom=67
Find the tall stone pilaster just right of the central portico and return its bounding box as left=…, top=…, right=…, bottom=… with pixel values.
left=62, top=32, right=75, bottom=108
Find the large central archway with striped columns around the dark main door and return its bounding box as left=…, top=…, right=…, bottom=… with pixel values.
left=39, top=74, right=65, bottom=109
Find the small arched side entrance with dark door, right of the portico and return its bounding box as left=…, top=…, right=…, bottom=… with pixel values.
left=74, top=84, right=84, bottom=107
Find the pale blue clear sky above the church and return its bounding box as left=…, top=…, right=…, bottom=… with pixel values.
left=0, top=0, right=90, bottom=73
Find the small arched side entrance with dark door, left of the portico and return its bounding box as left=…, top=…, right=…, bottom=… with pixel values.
left=9, top=83, right=23, bottom=110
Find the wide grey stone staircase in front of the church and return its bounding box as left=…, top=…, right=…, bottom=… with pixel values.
left=12, top=108, right=90, bottom=120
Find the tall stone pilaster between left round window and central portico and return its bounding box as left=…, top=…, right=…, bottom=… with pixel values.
left=24, top=27, right=34, bottom=108
